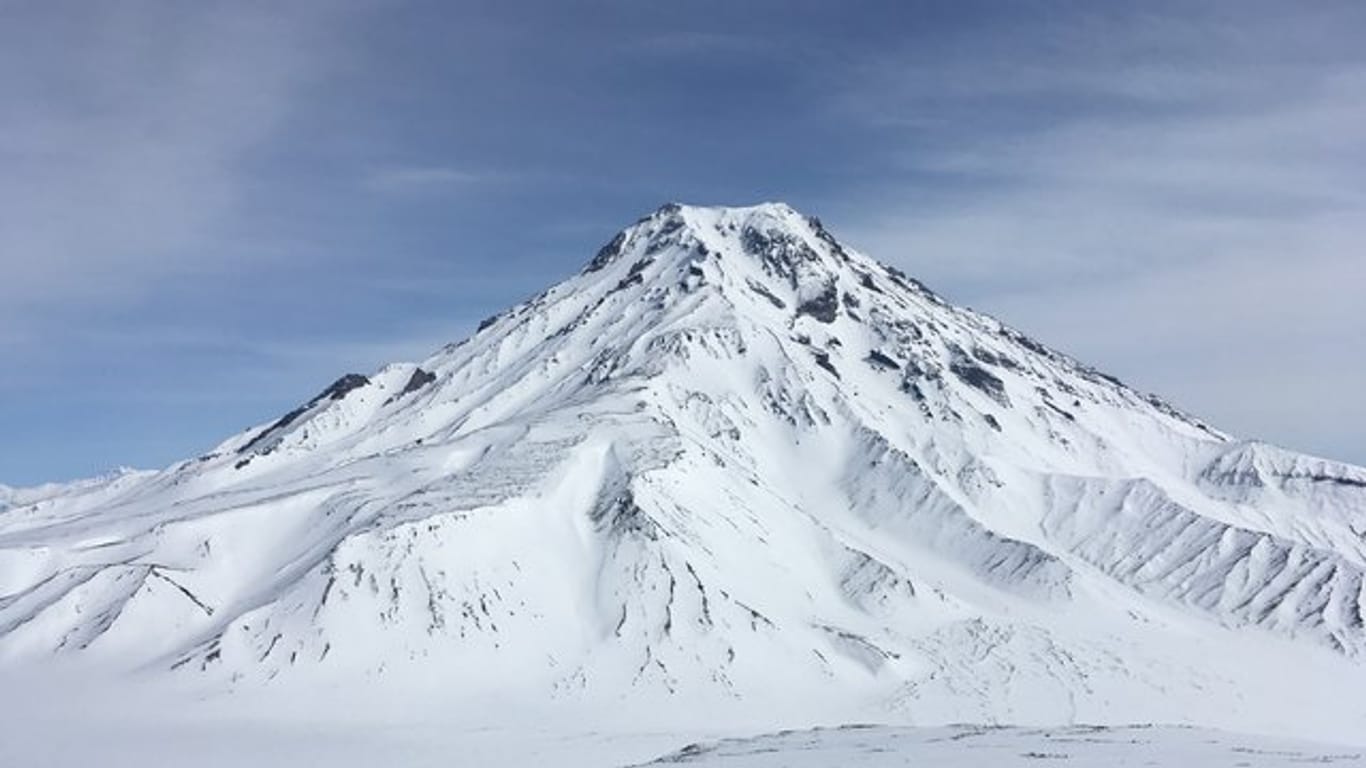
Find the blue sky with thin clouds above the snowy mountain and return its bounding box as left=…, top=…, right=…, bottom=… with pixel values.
left=0, top=0, right=1366, bottom=485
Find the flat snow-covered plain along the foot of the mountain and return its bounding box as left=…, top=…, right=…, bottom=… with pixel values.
left=0, top=675, right=1366, bottom=768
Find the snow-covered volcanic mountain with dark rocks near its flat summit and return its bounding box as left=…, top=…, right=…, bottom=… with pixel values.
left=0, top=204, right=1366, bottom=732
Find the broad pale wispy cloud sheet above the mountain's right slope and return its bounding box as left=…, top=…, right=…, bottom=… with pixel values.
left=840, top=7, right=1366, bottom=461
